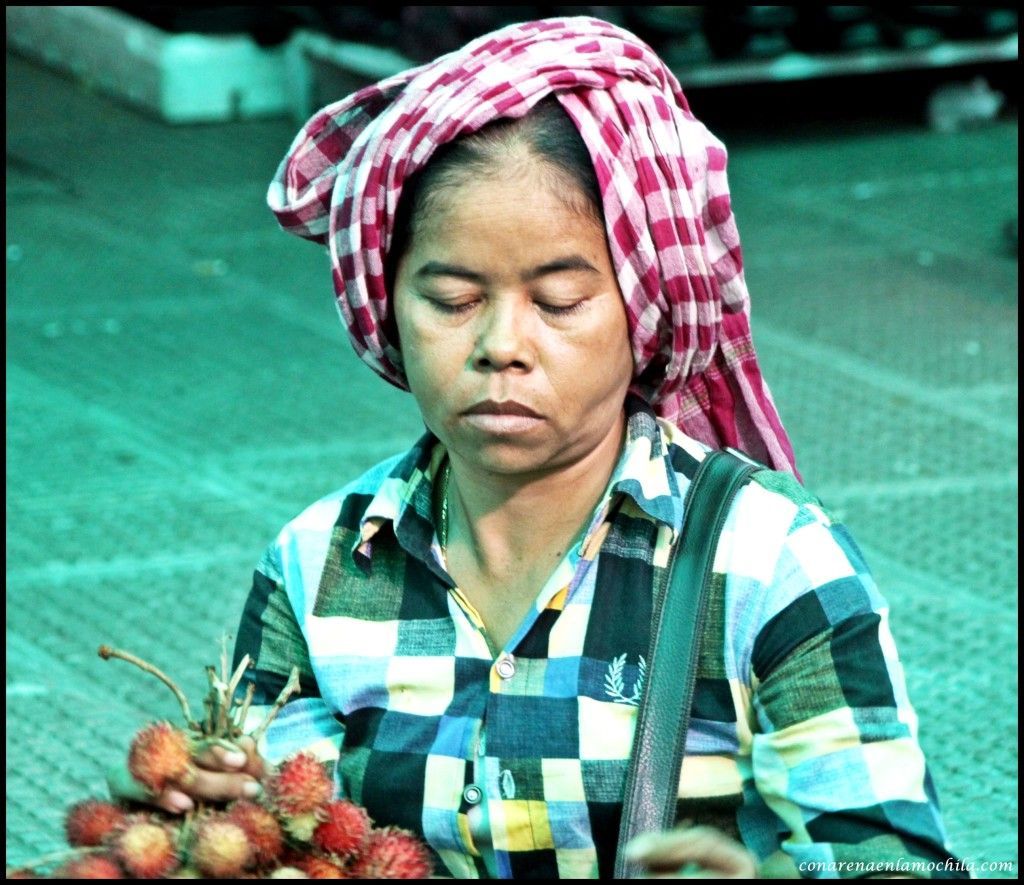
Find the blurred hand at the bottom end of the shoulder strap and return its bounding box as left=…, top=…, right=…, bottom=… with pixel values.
left=626, top=827, right=758, bottom=879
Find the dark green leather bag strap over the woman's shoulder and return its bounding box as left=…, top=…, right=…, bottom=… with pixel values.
left=614, top=450, right=763, bottom=879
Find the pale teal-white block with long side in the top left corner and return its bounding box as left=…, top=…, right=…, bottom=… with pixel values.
left=6, top=6, right=295, bottom=123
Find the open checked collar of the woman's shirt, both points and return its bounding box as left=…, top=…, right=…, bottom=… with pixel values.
left=351, top=393, right=683, bottom=565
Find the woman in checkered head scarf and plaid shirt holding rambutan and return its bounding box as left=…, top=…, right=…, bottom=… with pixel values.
left=116, top=13, right=962, bottom=878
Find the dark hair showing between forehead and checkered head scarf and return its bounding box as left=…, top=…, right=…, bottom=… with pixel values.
left=384, top=95, right=604, bottom=294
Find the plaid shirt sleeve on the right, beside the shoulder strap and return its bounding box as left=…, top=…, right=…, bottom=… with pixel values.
left=740, top=491, right=970, bottom=878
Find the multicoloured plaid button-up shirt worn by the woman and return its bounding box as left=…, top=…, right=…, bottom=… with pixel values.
left=236, top=396, right=949, bottom=878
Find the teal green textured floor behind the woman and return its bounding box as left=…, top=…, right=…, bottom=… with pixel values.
left=6, top=45, right=1017, bottom=878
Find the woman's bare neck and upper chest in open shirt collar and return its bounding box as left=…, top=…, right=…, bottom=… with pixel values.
left=446, top=413, right=626, bottom=579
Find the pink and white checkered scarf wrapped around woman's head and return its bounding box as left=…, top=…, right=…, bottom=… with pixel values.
left=267, top=16, right=797, bottom=473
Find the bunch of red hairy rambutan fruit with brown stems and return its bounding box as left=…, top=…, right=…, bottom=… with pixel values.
left=1, top=646, right=433, bottom=879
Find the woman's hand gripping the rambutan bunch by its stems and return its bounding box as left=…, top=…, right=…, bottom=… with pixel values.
left=106, top=736, right=269, bottom=814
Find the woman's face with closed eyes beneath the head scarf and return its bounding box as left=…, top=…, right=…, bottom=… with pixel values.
left=394, top=160, right=633, bottom=474
